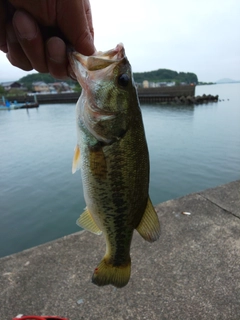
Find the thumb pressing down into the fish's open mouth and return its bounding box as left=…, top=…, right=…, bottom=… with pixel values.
left=57, top=0, right=95, bottom=55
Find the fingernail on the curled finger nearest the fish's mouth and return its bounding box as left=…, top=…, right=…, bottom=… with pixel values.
left=47, top=37, right=66, bottom=63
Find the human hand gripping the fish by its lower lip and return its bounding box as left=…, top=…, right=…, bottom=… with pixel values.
left=0, top=0, right=95, bottom=79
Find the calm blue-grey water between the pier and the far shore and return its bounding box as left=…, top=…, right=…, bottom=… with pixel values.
left=0, top=83, right=240, bottom=256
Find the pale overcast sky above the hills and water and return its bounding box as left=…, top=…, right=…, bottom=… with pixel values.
left=0, top=0, right=240, bottom=82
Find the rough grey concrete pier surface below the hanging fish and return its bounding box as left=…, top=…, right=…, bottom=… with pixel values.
left=0, top=180, right=240, bottom=320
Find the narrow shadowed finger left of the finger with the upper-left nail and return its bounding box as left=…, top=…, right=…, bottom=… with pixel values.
left=6, top=23, right=32, bottom=71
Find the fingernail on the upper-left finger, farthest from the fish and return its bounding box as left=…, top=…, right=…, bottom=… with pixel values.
left=13, top=10, right=37, bottom=41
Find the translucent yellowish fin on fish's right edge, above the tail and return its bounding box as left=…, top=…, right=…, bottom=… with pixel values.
left=136, top=198, right=160, bottom=242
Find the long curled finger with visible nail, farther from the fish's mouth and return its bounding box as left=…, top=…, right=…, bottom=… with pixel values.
left=13, top=10, right=48, bottom=73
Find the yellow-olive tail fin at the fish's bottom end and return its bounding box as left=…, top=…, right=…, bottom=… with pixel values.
left=92, top=257, right=131, bottom=288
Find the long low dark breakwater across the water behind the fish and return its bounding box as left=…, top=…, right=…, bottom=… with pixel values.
left=3, top=85, right=218, bottom=104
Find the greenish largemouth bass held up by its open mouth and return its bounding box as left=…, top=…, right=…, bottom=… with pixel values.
left=68, top=43, right=160, bottom=288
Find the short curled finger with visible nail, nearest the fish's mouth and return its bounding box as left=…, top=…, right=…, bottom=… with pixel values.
left=46, top=37, right=68, bottom=79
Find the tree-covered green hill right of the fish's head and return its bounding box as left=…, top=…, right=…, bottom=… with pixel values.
left=133, top=69, right=198, bottom=84
